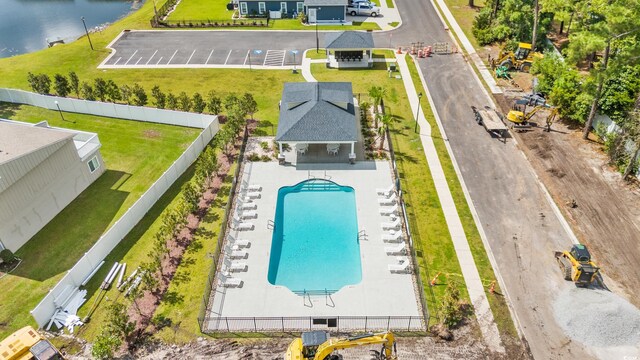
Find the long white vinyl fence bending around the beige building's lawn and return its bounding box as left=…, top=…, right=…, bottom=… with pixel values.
left=0, top=89, right=219, bottom=327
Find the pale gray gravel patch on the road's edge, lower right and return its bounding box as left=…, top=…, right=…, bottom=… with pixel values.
left=554, top=288, right=640, bottom=347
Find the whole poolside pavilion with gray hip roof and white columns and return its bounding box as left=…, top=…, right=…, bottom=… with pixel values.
left=275, top=82, right=364, bottom=164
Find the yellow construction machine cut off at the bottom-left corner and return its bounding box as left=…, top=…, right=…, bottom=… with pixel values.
left=0, top=326, right=64, bottom=360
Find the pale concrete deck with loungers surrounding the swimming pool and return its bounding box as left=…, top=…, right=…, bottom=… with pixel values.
left=208, top=161, right=422, bottom=330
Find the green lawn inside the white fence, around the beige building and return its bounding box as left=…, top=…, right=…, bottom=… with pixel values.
left=0, top=103, right=201, bottom=338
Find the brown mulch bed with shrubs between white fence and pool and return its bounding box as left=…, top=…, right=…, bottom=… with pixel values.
left=129, top=121, right=257, bottom=340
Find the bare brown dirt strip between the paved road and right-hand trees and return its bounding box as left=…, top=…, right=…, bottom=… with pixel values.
left=518, top=117, right=640, bottom=300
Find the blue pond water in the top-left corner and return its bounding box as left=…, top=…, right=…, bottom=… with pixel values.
left=0, top=0, right=143, bottom=58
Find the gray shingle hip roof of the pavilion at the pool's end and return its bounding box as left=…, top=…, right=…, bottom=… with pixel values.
left=276, top=82, right=358, bottom=143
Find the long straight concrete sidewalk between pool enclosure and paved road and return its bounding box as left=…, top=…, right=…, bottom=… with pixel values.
left=396, top=54, right=505, bottom=352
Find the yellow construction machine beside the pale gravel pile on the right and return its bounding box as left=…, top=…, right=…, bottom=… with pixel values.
left=555, top=244, right=600, bottom=287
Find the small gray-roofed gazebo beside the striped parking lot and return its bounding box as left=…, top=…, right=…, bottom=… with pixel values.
left=324, top=31, right=374, bottom=68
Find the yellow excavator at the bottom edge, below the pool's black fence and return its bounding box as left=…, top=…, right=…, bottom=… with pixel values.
left=285, top=331, right=398, bottom=360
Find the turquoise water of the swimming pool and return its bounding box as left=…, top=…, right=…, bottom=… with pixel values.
left=268, top=179, right=362, bottom=292
